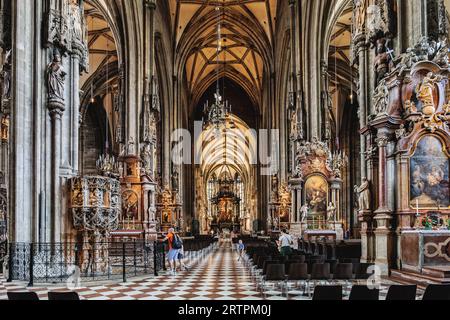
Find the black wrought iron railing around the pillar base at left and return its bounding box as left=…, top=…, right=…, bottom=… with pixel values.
left=8, top=241, right=165, bottom=286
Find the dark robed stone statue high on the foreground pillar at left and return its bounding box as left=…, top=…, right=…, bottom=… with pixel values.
left=47, top=48, right=67, bottom=101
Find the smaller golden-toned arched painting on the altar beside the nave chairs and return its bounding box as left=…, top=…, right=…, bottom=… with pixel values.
left=305, top=176, right=328, bottom=217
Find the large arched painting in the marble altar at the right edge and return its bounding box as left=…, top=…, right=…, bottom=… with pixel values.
left=410, top=135, right=450, bottom=209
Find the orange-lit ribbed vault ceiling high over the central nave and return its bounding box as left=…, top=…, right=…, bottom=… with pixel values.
left=169, top=0, right=278, bottom=106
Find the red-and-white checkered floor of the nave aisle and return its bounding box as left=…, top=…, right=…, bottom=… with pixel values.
left=0, top=243, right=422, bottom=300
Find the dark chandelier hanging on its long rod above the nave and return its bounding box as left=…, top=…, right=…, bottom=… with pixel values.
left=203, top=7, right=231, bottom=132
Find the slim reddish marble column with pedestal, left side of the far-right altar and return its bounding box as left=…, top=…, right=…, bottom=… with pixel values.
left=374, top=129, right=393, bottom=275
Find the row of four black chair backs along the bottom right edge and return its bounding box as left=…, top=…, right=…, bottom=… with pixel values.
left=313, top=284, right=450, bottom=301
